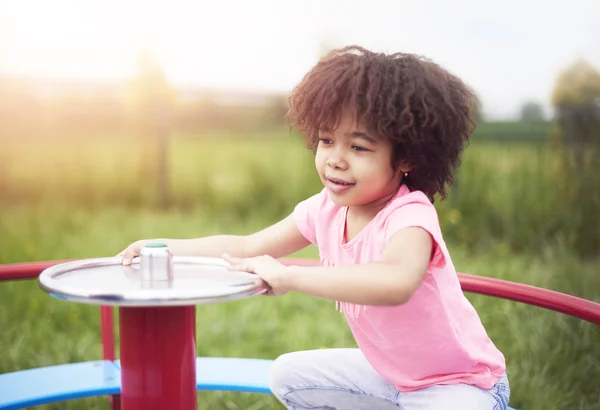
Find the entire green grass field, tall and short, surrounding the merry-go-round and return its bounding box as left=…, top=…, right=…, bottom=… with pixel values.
left=0, top=135, right=600, bottom=410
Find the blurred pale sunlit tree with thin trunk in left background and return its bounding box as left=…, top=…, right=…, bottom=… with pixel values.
left=127, top=51, right=177, bottom=208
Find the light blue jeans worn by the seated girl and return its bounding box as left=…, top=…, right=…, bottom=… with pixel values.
left=269, top=349, right=510, bottom=410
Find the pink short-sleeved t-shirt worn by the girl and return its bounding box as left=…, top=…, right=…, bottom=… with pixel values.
left=294, top=185, right=506, bottom=391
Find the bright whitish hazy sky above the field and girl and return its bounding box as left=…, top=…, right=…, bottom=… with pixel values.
left=0, top=0, right=600, bottom=118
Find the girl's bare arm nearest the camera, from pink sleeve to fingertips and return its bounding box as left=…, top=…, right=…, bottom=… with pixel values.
left=225, top=227, right=433, bottom=305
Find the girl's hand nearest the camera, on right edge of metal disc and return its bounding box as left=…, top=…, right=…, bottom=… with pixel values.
left=223, top=254, right=290, bottom=296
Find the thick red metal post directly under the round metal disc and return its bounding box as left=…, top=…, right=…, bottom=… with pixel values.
left=119, top=306, right=197, bottom=410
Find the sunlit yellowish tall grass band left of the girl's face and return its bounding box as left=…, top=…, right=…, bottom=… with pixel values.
left=0, top=130, right=318, bottom=216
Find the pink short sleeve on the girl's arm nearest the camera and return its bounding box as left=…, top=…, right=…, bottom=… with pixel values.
left=385, top=201, right=446, bottom=268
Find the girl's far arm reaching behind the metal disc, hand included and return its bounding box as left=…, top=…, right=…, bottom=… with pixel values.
left=121, top=215, right=310, bottom=265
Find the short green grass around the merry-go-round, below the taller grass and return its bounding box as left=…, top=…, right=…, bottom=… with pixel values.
left=0, top=208, right=600, bottom=410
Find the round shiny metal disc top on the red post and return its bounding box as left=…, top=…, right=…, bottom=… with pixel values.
left=38, top=253, right=266, bottom=306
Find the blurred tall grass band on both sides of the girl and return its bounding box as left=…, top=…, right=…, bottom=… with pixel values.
left=0, top=130, right=600, bottom=255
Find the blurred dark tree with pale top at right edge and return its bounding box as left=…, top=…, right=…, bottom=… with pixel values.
left=552, top=59, right=600, bottom=255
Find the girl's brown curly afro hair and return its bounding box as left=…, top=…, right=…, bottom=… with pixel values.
left=286, top=46, right=478, bottom=201
